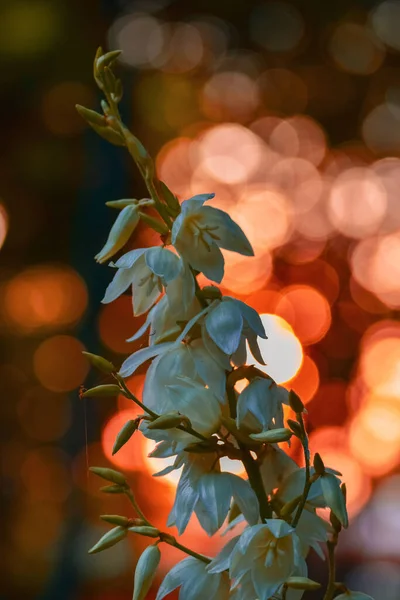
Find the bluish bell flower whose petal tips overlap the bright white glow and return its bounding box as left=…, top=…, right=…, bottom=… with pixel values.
left=205, top=296, right=267, bottom=360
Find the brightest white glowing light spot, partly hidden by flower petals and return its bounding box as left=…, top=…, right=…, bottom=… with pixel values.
left=247, top=314, right=303, bottom=383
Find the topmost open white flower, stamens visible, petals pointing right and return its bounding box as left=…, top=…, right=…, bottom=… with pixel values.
left=171, top=194, right=254, bottom=283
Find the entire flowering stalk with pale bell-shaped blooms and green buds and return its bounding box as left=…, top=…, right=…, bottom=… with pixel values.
left=79, top=50, right=376, bottom=600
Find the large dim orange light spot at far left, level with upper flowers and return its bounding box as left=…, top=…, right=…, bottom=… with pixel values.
left=4, top=266, right=88, bottom=334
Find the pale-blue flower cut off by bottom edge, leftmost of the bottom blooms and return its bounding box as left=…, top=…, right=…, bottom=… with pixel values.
left=156, top=557, right=229, bottom=600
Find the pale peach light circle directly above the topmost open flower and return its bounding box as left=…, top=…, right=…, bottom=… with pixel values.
left=198, top=123, right=262, bottom=184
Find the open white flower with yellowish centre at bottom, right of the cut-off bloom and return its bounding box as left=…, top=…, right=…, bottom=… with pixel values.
left=207, top=519, right=304, bottom=600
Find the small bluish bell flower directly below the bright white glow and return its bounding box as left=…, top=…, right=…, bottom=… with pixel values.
left=236, top=377, right=288, bottom=433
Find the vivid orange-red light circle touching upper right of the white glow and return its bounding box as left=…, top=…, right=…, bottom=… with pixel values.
left=276, top=285, right=331, bottom=345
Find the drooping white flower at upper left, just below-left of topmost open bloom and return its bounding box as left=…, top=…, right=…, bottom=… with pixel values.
left=103, top=246, right=194, bottom=316
